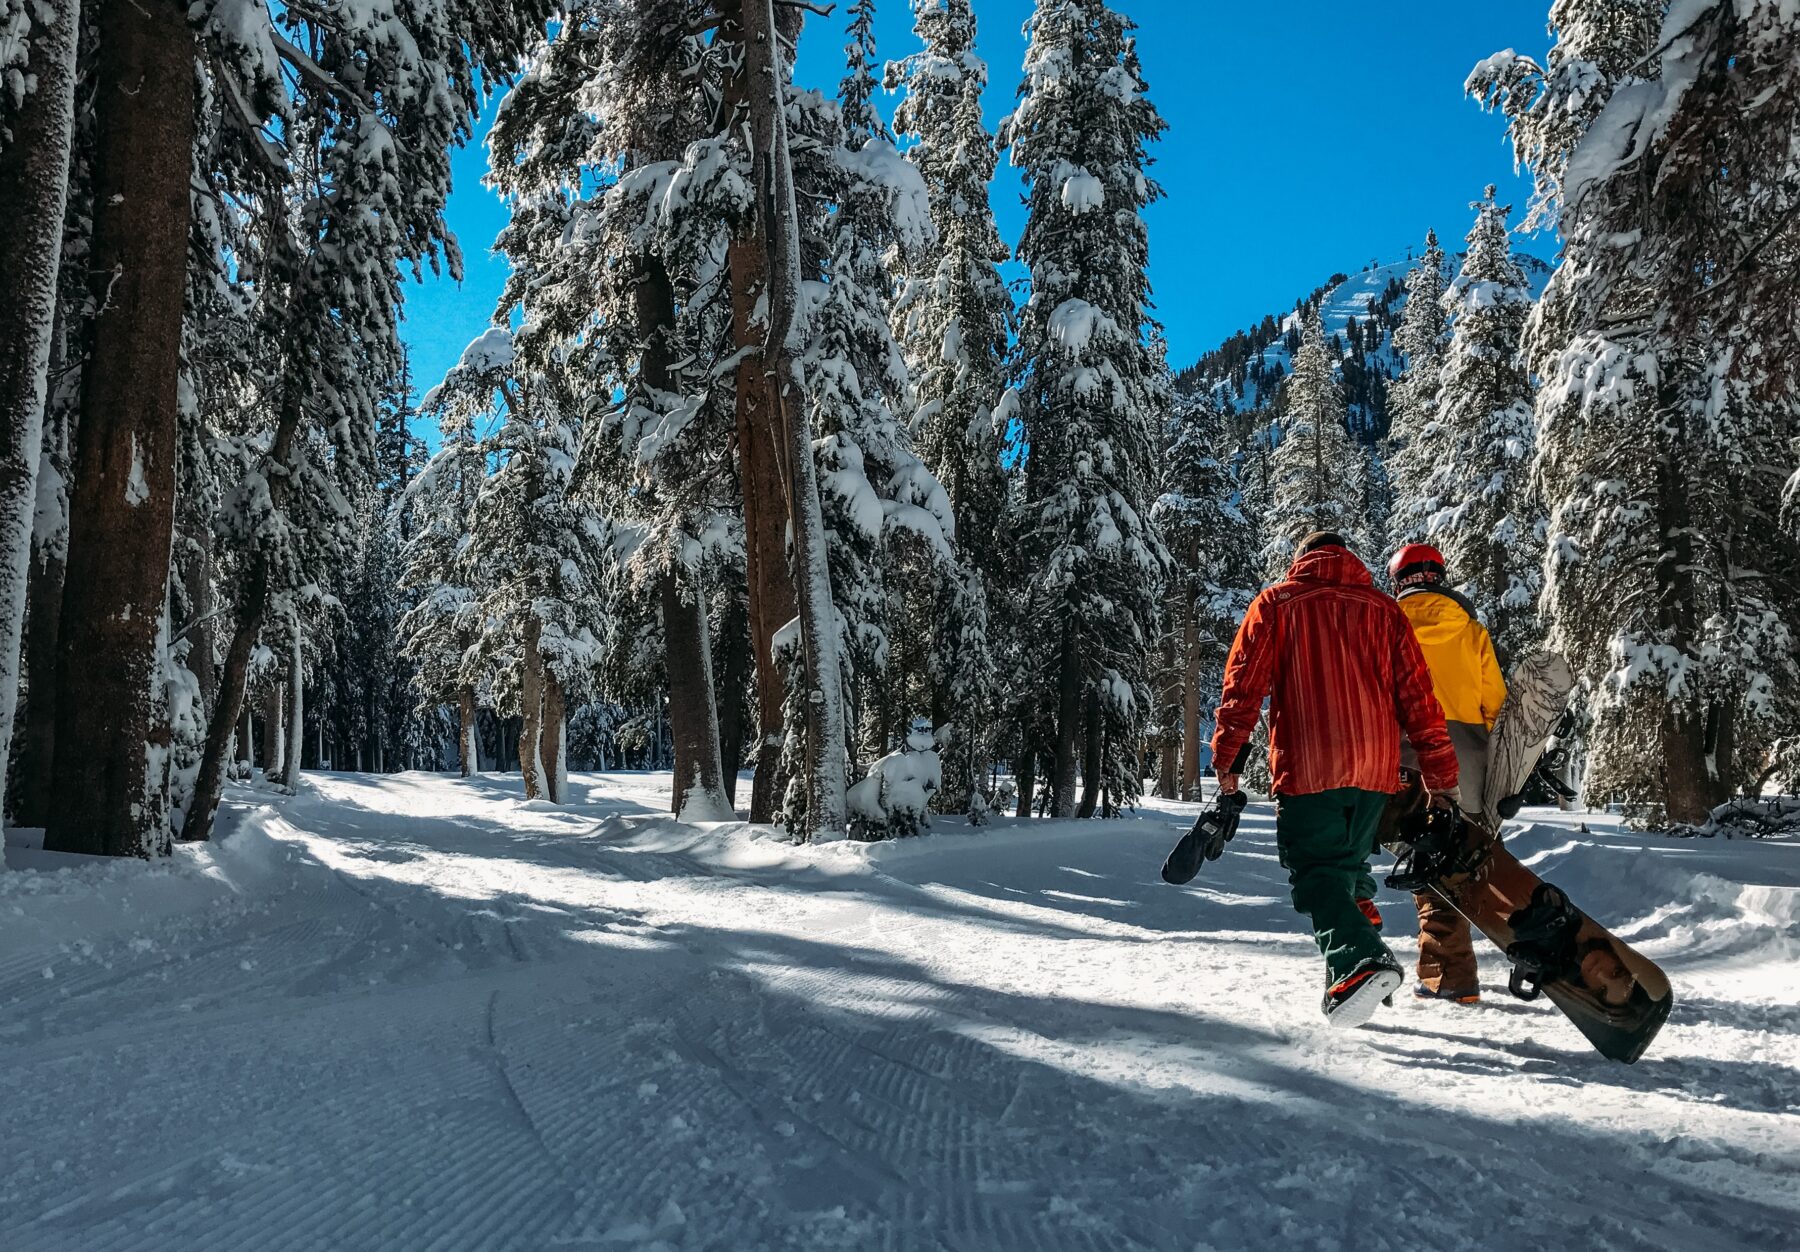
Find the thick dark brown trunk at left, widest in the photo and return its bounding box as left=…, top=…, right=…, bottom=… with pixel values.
left=45, top=0, right=194, bottom=856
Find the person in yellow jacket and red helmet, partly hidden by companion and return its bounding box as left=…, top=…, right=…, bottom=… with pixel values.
left=1388, top=543, right=1507, bottom=1004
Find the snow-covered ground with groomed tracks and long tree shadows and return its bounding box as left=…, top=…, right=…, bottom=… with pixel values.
left=0, top=775, right=1800, bottom=1252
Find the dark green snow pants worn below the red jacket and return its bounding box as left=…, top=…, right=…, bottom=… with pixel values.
left=1274, top=786, right=1393, bottom=986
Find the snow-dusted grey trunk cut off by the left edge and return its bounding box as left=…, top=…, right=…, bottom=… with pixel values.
left=0, top=0, right=81, bottom=820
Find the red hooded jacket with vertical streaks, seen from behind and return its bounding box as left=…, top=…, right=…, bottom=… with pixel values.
left=1213, top=545, right=1456, bottom=795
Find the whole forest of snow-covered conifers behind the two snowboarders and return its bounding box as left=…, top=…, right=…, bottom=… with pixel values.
left=0, top=0, right=1800, bottom=856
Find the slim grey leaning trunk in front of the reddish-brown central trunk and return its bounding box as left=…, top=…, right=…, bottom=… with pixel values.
left=743, top=0, right=848, bottom=840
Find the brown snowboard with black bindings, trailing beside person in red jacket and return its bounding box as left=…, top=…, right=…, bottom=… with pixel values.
left=1381, top=775, right=1674, bottom=1065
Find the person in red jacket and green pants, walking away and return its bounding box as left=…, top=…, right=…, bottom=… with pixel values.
left=1213, top=531, right=1458, bottom=1025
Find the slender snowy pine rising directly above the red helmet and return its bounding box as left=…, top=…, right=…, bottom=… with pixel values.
left=1382, top=230, right=1451, bottom=547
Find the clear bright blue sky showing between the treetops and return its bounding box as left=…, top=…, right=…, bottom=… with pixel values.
left=403, top=0, right=1553, bottom=392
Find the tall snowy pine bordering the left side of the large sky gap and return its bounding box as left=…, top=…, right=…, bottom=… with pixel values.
left=1001, top=0, right=1170, bottom=817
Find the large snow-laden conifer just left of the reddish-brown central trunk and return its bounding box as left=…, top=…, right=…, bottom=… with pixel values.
left=490, top=0, right=738, bottom=820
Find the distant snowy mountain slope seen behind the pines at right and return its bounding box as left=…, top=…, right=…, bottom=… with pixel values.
left=1175, top=252, right=1552, bottom=432
